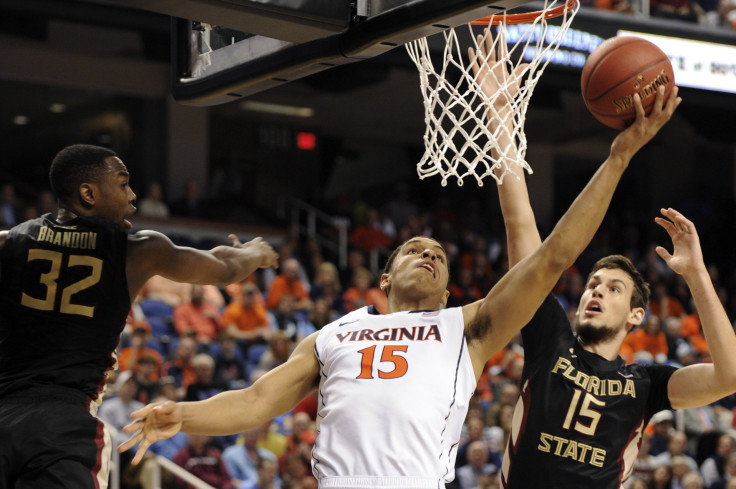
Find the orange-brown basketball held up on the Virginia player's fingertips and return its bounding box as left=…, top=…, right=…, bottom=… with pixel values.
left=580, top=36, right=675, bottom=130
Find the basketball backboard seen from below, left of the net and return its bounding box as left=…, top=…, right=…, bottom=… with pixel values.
left=125, top=0, right=528, bottom=106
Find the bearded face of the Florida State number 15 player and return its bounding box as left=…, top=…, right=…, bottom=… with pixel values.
left=577, top=268, right=643, bottom=330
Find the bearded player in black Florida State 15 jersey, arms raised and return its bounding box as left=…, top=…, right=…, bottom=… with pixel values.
left=478, top=51, right=736, bottom=489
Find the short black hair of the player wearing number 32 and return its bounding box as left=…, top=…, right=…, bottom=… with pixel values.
left=49, top=144, right=117, bottom=204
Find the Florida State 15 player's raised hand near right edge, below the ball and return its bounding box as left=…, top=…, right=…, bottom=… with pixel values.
left=654, top=208, right=705, bottom=276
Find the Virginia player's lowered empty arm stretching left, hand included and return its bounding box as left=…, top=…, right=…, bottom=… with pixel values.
left=118, top=333, right=319, bottom=464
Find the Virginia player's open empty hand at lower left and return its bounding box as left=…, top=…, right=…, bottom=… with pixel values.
left=118, top=401, right=182, bottom=465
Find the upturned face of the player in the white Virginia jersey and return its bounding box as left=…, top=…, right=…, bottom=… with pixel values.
left=381, top=237, right=449, bottom=304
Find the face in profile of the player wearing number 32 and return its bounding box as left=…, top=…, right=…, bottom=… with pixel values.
left=95, top=156, right=136, bottom=227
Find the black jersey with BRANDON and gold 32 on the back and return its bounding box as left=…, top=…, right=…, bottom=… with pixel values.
left=0, top=214, right=130, bottom=400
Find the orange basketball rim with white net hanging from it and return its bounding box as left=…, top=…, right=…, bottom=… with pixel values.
left=406, top=0, right=580, bottom=187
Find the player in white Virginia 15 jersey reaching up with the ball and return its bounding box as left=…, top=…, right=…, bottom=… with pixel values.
left=120, top=43, right=677, bottom=489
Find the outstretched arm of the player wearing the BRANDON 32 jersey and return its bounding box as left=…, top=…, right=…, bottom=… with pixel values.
left=127, top=231, right=278, bottom=297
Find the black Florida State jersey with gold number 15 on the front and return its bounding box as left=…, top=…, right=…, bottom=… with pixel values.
left=501, top=295, right=675, bottom=489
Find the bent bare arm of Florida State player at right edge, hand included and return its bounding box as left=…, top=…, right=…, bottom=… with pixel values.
left=655, top=209, right=736, bottom=409
